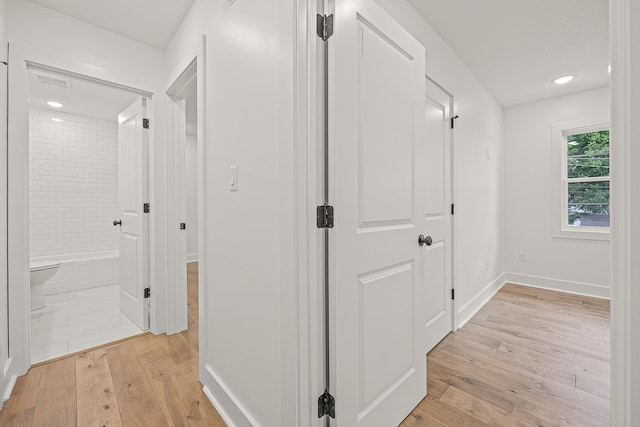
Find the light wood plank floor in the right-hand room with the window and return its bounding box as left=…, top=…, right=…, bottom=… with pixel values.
left=401, top=285, right=611, bottom=427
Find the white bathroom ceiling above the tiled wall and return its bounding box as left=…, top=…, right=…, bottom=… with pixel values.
left=28, top=68, right=140, bottom=122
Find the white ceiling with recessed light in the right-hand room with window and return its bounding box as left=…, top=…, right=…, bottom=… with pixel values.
left=408, top=0, right=609, bottom=107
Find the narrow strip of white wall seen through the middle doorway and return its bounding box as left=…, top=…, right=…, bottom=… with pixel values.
left=185, top=134, right=198, bottom=261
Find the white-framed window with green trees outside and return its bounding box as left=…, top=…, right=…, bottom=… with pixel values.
left=552, top=121, right=610, bottom=240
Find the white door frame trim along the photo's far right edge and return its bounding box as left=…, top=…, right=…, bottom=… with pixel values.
left=609, top=0, right=640, bottom=426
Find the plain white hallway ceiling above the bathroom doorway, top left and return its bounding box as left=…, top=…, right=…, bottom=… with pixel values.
left=26, top=0, right=194, bottom=50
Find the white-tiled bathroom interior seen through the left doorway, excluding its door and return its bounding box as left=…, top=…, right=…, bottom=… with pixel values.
left=27, top=66, right=149, bottom=364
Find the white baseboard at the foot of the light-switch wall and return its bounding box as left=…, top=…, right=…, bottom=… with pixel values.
left=201, top=365, right=259, bottom=427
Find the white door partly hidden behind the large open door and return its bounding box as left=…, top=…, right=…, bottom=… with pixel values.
left=421, top=78, right=453, bottom=351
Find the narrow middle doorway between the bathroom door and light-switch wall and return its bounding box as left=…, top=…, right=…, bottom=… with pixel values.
left=166, top=43, right=205, bottom=352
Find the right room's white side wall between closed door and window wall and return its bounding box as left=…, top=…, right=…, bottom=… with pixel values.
left=376, top=0, right=504, bottom=325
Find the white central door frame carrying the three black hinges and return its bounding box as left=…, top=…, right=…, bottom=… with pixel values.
left=294, top=0, right=328, bottom=427
